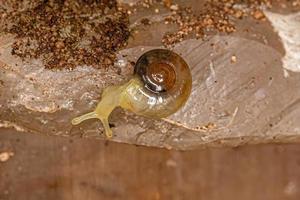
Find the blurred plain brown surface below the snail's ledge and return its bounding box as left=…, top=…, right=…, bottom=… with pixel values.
left=0, top=129, right=300, bottom=200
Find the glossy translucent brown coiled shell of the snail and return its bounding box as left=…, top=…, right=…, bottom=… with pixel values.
left=122, top=49, right=192, bottom=118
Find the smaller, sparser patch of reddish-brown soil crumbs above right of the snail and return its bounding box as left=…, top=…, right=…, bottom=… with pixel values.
left=162, top=0, right=272, bottom=46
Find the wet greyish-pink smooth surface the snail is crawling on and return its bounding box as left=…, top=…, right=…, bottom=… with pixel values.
left=0, top=0, right=300, bottom=150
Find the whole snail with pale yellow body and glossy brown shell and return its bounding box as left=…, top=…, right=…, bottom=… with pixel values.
left=72, top=49, right=192, bottom=138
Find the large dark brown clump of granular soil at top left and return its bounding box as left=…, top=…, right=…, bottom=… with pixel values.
left=0, top=0, right=130, bottom=69
